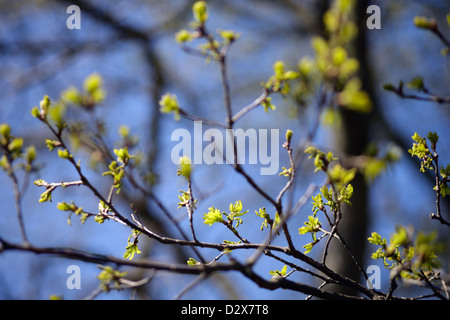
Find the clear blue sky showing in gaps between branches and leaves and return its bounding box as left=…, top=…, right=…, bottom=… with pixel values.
left=0, top=1, right=450, bottom=299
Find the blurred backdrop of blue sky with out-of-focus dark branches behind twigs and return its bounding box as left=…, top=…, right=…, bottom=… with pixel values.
left=0, top=0, right=450, bottom=299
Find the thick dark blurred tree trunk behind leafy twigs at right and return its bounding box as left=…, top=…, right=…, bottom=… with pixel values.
left=327, top=0, right=370, bottom=294
